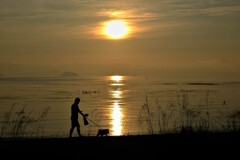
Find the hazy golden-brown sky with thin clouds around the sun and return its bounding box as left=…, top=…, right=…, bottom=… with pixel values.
left=0, top=0, right=240, bottom=80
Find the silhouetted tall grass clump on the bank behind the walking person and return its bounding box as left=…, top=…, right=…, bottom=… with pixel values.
left=0, top=104, right=50, bottom=138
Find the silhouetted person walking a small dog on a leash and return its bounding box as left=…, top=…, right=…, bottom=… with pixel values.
left=69, top=97, right=88, bottom=137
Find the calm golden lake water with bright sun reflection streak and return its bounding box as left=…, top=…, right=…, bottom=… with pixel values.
left=0, top=76, right=240, bottom=136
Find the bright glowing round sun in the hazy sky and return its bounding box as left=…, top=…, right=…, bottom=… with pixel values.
left=104, top=20, right=129, bottom=39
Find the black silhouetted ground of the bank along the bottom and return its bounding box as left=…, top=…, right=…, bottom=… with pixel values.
left=0, top=132, right=240, bottom=159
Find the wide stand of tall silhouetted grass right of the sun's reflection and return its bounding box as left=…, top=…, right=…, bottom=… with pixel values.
left=138, top=90, right=240, bottom=134
